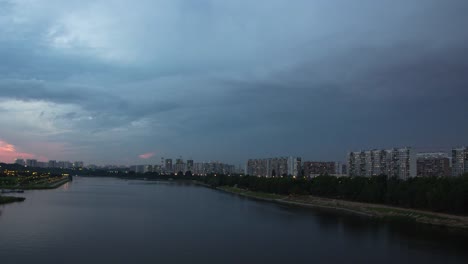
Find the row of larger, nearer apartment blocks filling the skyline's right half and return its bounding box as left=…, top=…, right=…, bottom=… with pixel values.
left=245, top=147, right=468, bottom=179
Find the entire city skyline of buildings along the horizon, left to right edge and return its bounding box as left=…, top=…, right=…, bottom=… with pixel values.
left=9, top=147, right=468, bottom=179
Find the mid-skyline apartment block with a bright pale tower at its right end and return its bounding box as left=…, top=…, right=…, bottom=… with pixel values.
left=245, top=157, right=301, bottom=177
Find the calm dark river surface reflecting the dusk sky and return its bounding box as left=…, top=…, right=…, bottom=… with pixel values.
left=0, top=177, right=468, bottom=264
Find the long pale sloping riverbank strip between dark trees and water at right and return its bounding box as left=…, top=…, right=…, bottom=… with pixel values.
left=216, top=186, right=468, bottom=230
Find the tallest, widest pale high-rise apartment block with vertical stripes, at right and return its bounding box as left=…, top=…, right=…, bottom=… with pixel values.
left=348, top=148, right=416, bottom=179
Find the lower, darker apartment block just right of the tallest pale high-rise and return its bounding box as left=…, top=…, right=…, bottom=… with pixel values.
left=416, top=153, right=451, bottom=177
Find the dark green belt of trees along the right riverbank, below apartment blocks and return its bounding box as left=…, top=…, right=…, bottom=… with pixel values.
left=194, top=175, right=468, bottom=215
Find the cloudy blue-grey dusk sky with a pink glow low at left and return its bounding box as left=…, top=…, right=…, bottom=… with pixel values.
left=0, top=0, right=468, bottom=165
